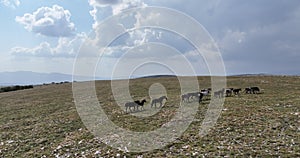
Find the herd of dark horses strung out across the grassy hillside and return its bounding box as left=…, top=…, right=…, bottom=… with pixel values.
left=125, top=87, right=260, bottom=112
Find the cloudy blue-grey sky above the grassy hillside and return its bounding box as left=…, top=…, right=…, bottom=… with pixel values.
left=0, top=0, right=300, bottom=77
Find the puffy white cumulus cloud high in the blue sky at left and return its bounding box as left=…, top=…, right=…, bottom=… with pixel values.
left=16, top=5, right=75, bottom=37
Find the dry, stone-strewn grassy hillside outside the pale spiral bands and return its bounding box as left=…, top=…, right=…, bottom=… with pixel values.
left=0, top=76, right=300, bottom=157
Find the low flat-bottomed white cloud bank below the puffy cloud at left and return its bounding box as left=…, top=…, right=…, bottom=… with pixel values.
left=11, top=33, right=87, bottom=57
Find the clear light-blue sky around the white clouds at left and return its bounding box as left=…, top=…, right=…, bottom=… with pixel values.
left=0, top=0, right=93, bottom=74
